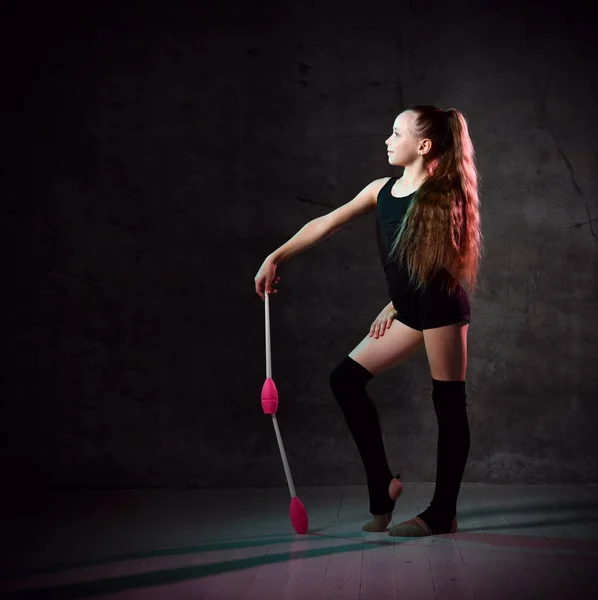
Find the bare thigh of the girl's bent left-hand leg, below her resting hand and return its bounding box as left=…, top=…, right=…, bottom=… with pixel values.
left=349, top=319, right=425, bottom=375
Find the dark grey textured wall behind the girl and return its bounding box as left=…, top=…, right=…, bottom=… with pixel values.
left=0, top=0, right=598, bottom=487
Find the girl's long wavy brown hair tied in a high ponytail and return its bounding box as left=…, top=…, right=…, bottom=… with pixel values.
left=389, top=105, right=483, bottom=298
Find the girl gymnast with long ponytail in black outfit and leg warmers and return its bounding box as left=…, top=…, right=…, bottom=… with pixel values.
left=255, top=105, right=483, bottom=537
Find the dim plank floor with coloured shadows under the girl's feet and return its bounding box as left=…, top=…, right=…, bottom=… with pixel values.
left=0, top=484, right=598, bottom=600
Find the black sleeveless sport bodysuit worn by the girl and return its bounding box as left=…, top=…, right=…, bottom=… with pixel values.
left=376, top=177, right=471, bottom=331
